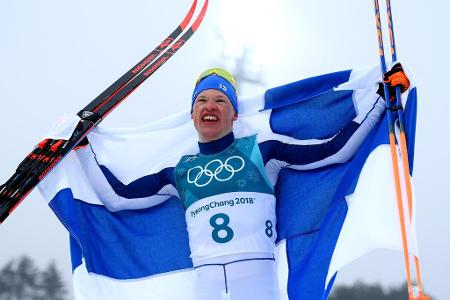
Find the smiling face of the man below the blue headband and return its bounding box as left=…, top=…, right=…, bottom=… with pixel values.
left=192, top=89, right=237, bottom=142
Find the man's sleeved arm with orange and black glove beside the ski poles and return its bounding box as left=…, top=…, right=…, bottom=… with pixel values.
left=258, top=64, right=409, bottom=170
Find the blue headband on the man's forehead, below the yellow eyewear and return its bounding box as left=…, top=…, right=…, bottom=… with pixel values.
left=191, top=74, right=238, bottom=113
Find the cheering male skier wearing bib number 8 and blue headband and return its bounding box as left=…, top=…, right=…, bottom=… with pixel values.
left=81, top=68, right=406, bottom=300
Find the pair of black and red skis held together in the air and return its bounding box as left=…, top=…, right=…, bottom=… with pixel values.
left=0, top=0, right=208, bottom=223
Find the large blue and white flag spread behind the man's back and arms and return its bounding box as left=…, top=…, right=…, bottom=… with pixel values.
left=39, top=69, right=417, bottom=300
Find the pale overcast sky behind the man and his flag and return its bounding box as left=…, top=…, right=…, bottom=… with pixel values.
left=0, top=0, right=450, bottom=300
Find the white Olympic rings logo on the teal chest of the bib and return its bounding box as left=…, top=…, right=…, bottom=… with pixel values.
left=187, top=156, right=245, bottom=187
